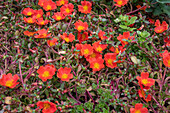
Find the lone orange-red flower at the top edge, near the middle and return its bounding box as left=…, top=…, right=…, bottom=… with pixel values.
left=78, top=1, right=92, bottom=14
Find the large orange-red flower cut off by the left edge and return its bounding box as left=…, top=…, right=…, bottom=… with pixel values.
left=0, top=73, right=19, bottom=88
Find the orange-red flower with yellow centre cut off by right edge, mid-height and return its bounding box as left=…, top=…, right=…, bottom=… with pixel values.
left=162, top=50, right=170, bottom=67
